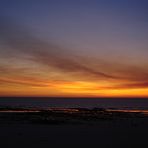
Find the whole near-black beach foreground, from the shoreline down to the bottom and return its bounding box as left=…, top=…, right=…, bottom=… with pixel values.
left=0, top=110, right=148, bottom=148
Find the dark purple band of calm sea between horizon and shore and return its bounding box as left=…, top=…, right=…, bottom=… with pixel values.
left=0, top=97, right=148, bottom=109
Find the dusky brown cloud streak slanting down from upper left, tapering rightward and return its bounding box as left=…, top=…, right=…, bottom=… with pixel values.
left=0, top=19, right=117, bottom=79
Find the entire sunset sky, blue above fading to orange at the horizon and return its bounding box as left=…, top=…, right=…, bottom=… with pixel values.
left=0, top=0, right=148, bottom=97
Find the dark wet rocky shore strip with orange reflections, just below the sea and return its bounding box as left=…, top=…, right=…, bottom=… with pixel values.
left=0, top=107, right=148, bottom=124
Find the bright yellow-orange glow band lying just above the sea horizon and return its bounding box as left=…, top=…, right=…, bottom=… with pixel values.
left=0, top=78, right=148, bottom=97
